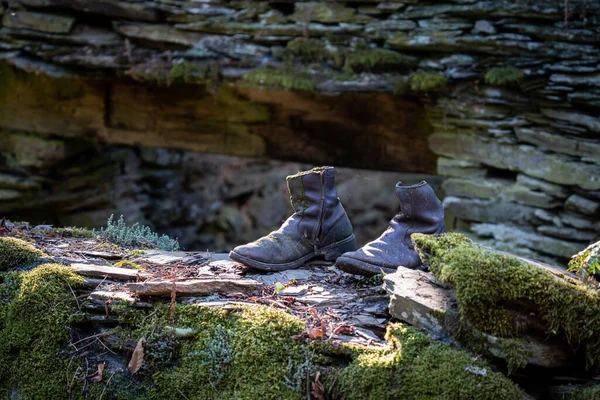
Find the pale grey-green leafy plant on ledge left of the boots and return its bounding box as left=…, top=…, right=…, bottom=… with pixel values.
left=98, top=215, right=179, bottom=251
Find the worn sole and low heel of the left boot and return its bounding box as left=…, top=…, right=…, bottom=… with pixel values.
left=229, top=234, right=358, bottom=272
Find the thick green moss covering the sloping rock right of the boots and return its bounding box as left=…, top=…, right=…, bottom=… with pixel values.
left=412, top=233, right=600, bottom=365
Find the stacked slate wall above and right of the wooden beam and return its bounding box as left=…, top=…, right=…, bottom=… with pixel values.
left=0, top=0, right=600, bottom=261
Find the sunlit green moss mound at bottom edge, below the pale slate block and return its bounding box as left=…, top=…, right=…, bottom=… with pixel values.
left=333, top=324, right=523, bottom=400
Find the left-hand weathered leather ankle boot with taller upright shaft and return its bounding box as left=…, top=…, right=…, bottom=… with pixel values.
left=229, top=167, right=358, bottom=271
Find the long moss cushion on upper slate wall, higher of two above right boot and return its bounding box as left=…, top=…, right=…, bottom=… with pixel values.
left=344, top=49, right=415, bottom=72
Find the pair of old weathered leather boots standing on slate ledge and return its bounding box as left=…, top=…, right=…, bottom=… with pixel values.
left=229, top=167, right=445, bottom=275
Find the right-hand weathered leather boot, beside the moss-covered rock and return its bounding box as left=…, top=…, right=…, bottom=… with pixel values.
left=335, top=181, right=446, bottom=275
